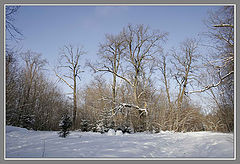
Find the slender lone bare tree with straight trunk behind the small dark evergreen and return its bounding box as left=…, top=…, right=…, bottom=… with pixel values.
left=55, top=45, right=86, bottom=128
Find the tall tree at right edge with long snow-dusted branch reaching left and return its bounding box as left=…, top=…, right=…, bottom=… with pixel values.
left=188, top=6, right=235, bottom=131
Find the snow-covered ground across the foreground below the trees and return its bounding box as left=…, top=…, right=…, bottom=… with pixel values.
left=5, top=126, right=234, bottom=158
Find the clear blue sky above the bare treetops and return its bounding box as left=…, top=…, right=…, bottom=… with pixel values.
left=9, top=6, right=221, bottom=96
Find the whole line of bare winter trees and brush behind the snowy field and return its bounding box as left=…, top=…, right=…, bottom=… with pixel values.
left=6, top=6, right=234, bottom=132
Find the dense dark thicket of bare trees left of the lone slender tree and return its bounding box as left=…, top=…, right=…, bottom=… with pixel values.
left=5, top=51, right=71, bottom=130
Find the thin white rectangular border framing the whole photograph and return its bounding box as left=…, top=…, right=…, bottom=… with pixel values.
left=3, top=3, right=237, bottom=161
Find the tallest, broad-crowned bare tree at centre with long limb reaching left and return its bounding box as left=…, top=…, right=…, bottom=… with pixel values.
left=90, top=25, right=167, bottom=113
